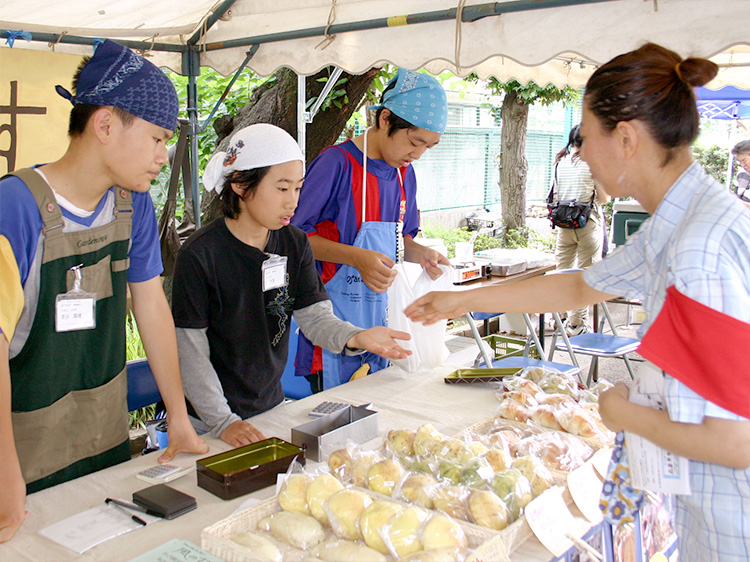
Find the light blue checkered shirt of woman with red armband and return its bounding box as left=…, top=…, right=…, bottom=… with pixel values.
left=584, top=163, right=750, bottom=562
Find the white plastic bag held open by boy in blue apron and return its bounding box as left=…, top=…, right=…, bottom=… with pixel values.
left=388, top=263, right=453, bottom=373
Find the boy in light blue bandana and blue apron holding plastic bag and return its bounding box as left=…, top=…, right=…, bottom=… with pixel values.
left=292, top=69, right=449, bottom=390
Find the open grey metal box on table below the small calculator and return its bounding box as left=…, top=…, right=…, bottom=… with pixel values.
left=292, top=406, right=378, bottom=461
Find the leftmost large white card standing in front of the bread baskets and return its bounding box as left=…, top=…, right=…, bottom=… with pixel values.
left=524, top=486, right=591, bottom=556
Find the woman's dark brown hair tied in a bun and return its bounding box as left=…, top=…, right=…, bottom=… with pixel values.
left=584, top=43, right=719, bottom=164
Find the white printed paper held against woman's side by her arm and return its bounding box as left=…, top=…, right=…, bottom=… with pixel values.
left=625, top=361, right=690, bottom=494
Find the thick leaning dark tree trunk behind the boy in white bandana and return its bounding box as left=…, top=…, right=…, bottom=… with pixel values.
left=201, top=68, right=380, bottom=224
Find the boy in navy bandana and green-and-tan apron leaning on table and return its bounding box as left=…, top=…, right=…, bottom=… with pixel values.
left=0, top=37, right=208, bottom=542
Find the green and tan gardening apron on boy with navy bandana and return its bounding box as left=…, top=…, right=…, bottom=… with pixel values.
left=10, top=169, right=133, bottom=493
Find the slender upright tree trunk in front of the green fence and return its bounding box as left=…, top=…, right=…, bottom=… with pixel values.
left=500, top=91, right=529, bottom=231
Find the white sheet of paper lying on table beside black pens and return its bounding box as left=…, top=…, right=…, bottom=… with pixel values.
left=39, top=504, right=160, bottom=554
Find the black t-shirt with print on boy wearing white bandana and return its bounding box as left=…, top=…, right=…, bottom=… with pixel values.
left=172, top=218, right=328, bottom=419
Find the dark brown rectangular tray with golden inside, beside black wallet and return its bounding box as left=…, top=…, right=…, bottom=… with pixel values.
left=200, top=437, right=305, bottom=500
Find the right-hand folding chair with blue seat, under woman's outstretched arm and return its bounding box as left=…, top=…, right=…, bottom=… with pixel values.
left=549, top=302, right=641, bottom=386
